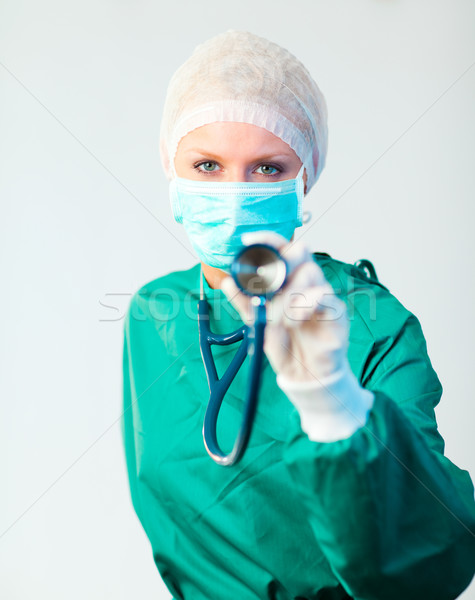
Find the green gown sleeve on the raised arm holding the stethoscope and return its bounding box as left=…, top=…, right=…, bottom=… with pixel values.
left=284, top=258, right=475, bottom=600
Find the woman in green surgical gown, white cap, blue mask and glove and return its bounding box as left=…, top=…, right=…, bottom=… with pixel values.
left=122, top=31, right=475, bottom=600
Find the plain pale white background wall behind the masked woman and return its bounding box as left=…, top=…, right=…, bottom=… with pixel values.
left=0, top=0, right=475, bottom=600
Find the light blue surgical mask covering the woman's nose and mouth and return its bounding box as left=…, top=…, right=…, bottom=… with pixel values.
left=170, top=165, right=304, bottom=271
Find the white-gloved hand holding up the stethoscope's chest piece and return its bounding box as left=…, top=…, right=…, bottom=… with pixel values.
left=222, top=232, right=374, bottom=441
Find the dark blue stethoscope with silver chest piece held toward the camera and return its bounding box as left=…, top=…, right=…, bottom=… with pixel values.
left=198, top=244, right=291, bottom=466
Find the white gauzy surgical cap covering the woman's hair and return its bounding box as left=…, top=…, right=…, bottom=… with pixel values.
left=160, top=30, right=328, bottom=190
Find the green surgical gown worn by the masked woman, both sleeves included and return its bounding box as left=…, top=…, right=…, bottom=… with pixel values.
left=122, top=253, right=475, bottom=600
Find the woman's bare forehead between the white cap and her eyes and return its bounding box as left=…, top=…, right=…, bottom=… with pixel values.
left=177, top=121, right=297, bottom=158
